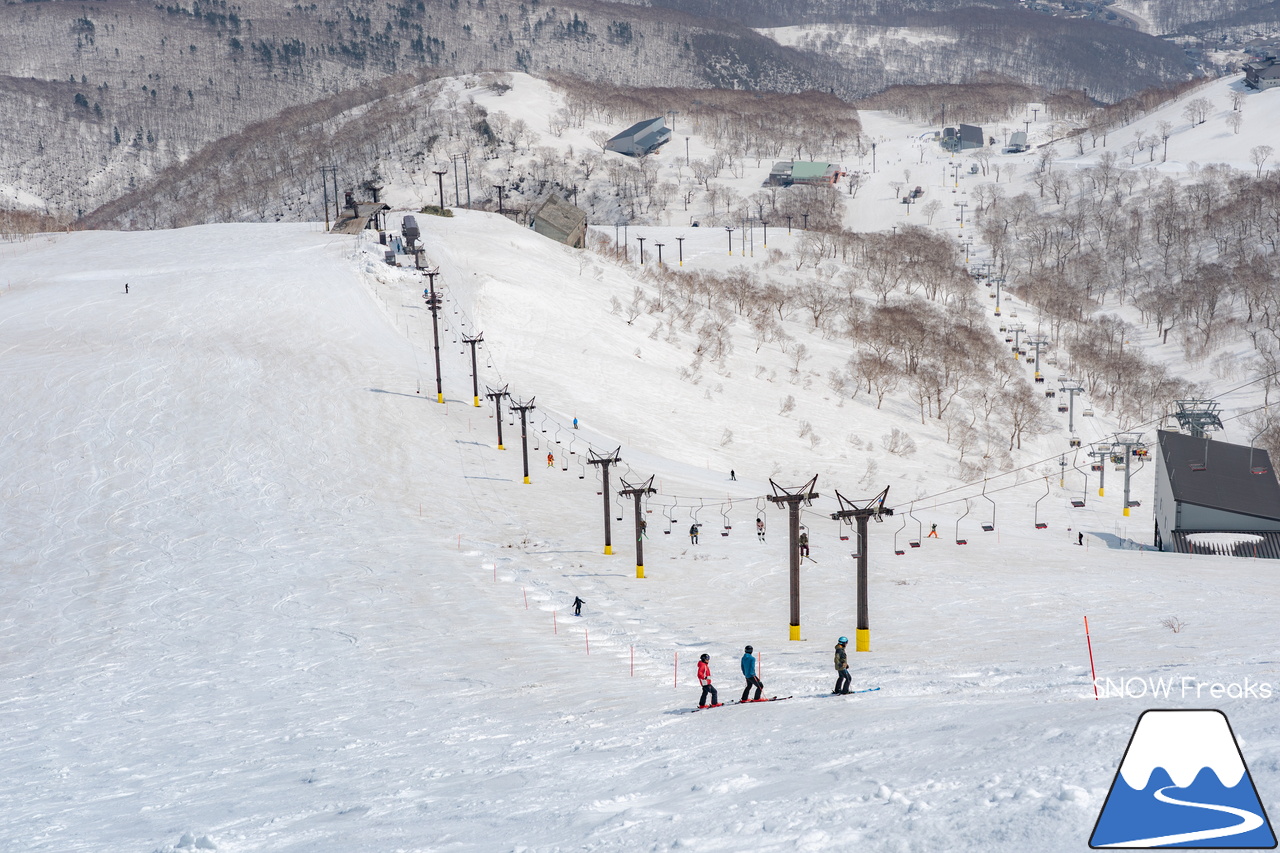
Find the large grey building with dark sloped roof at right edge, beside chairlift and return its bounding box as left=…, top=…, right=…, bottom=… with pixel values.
left=1155, top=429, right=1280, bottom=558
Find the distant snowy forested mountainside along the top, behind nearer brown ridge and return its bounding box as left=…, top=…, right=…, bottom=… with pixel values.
left=0, top=0, right=1193, bottom=225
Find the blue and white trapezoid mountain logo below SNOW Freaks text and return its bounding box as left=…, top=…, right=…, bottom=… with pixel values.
left=1089, top=711, right=1276, bottom=850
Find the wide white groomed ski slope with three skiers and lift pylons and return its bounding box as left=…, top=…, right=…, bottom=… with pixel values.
left=0, top=214, right=1280, bottom=853
